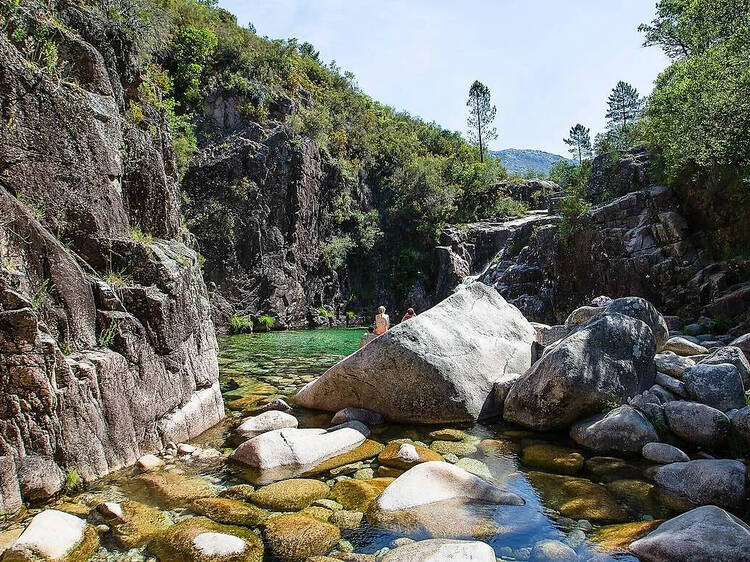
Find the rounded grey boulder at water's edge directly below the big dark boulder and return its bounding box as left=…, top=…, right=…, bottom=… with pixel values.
left=570, top=405, right=659, bottom=453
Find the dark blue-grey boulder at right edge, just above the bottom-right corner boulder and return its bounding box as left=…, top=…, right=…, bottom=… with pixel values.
left=652, top=459, right=746, bottom=510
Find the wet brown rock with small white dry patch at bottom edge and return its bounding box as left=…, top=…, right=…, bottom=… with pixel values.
left=148, top=517, right=263, bottom=562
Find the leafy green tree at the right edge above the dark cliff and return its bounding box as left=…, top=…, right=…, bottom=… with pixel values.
left=641, top=0, right=750, bottom=247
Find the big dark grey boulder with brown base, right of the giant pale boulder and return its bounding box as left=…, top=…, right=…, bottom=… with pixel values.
left=504, top=310, right=656, bottom=431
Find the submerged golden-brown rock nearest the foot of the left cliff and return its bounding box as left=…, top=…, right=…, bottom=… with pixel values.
left=126, top=472, right=214, bottom=509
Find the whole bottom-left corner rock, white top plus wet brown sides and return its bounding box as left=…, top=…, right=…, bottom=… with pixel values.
left=2, top=509, right=99, bottom=562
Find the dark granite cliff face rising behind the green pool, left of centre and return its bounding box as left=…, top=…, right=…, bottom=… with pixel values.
left=183, top=117, right=364, bottom=328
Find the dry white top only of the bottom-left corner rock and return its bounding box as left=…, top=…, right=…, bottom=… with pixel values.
left=9, top=509, right=86, bottom=560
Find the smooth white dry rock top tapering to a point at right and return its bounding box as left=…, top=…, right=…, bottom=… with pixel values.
left=373, top=461, right=525, bottom=511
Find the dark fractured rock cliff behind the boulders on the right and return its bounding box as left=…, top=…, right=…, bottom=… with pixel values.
left=436, top=186, right=750, bottom=331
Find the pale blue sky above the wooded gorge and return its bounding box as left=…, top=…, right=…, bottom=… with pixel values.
left=219, top=0, right=669, bottom=156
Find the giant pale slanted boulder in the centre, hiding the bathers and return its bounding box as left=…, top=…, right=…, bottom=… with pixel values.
left=295, top=283, right=536, bottom=423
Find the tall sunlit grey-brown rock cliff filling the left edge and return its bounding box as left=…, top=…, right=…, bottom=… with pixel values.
left=0, top=2, right=223, bottom=513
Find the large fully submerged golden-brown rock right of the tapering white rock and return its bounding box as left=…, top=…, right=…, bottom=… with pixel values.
left=527, top=471, right=628, bottom=523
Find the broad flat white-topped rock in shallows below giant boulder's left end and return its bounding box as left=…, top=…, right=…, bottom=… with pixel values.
left=231, top=422, right=370, bottom=469
